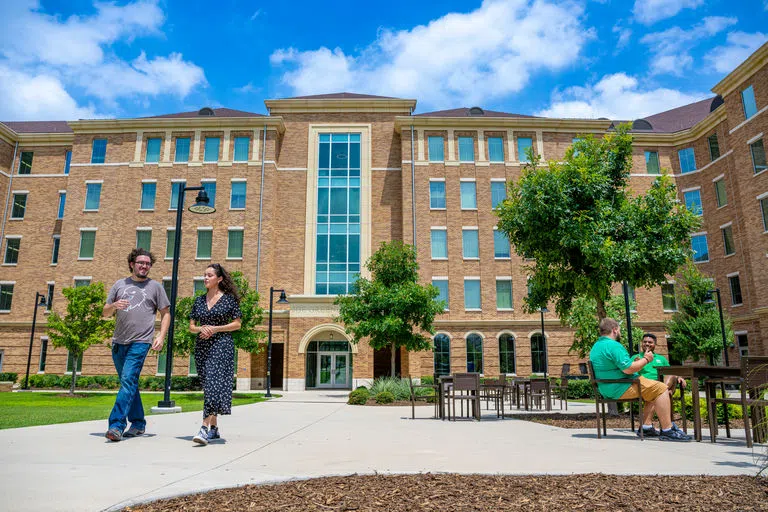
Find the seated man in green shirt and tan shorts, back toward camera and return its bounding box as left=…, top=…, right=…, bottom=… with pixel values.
left=589, top=318, right=691, bottom=441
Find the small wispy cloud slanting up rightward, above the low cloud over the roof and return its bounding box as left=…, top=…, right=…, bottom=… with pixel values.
left=640, top=16, right=738, bottom=76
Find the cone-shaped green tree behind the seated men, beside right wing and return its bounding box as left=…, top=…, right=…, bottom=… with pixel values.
left=666, top=263, right=733, bottom=361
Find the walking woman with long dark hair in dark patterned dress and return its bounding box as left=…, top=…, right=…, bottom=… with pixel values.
left=189, top=263, right=242, bottom=445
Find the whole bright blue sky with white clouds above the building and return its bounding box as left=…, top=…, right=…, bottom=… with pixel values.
left=0, top=0, right=768, bottom=120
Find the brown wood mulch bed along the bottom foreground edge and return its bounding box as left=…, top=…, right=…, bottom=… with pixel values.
left=123, top=473, right=768, bottom=512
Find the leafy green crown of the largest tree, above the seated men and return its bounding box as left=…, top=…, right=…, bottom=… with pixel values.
left=497, top=125, right=698, bottom=319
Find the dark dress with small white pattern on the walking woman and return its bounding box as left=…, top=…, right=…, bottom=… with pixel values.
left=189, top=294, right=242, bottom=418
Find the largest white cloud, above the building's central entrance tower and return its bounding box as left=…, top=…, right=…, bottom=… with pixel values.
left=270, top=0, right=594, bottom=108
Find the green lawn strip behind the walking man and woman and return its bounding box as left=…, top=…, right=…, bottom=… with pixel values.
left=0, top=391, right=265, bottom=429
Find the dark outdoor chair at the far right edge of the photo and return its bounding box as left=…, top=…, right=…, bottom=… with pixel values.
left=706, top=356, right=768, bottom=448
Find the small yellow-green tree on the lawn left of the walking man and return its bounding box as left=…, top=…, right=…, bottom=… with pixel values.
left=47, top=282, right=115, bottom=395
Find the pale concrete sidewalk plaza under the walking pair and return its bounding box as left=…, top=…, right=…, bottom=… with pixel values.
left=0, top=391, right=765, bottom=511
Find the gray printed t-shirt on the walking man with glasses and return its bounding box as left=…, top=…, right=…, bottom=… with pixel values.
left=107, top=277, right=171, bottom=345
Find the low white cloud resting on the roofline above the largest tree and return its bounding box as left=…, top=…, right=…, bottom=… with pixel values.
left=536, top=73, right=708, bottom=120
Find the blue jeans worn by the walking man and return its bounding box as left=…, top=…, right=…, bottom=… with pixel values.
left=109, top=343, right=150, bottom=432
